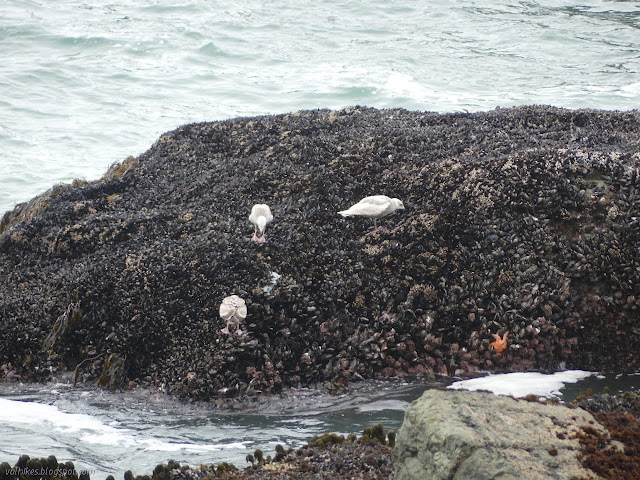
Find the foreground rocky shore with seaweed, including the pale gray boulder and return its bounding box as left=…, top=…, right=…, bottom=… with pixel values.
left=0, top=389, right=640, bottom=480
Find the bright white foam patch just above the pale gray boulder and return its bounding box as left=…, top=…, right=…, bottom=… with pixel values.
left=448, top=370, right=595, bottom=398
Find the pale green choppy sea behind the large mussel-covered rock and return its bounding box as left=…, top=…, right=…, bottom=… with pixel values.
left=0, top=0, right=640, bottom=213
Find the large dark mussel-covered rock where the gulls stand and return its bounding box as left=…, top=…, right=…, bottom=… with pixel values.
left=0, top=107, right=640, bottom=403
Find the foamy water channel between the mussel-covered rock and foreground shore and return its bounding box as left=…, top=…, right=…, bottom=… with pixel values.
left=0, top=371, right=640, bottom=479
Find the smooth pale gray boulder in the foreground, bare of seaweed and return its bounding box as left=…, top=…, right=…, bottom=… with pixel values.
left=395, top=390, right=606, bottom=480
